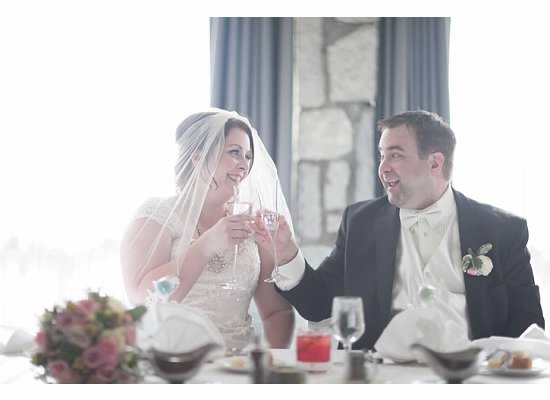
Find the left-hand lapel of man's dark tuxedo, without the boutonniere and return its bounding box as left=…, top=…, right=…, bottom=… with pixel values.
left=374, top=206, right=401, bottom=326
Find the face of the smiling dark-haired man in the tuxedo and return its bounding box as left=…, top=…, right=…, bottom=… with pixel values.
left=378, top=125, right=435, bottom=209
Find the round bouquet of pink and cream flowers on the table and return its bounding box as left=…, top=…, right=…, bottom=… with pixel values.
left=32, top=292, right=146, bottom=383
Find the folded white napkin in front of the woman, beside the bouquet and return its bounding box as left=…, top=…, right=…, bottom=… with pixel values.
left=137, top=303, right=224, bottom=355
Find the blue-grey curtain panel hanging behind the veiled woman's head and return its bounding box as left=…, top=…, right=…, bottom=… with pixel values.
left=210, top=18, right=293, bottom=199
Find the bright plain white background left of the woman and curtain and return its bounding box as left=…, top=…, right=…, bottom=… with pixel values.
left=0, top=1, right=210, bottom=326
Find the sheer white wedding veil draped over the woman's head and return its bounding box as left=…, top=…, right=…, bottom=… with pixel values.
left=126, top=108, right=294, bottom=300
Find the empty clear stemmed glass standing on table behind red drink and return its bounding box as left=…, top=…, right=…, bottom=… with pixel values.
left=331, top=296, right=365, bottom=352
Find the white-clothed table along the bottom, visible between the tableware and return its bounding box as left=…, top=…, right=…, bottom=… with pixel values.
left=0, top=349, right=550, bottom=384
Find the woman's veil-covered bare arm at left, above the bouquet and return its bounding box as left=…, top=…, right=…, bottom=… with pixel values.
left=120, top=219, right=208, bottom=304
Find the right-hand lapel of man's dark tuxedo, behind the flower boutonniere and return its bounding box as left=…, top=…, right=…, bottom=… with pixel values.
left=453, top=190, right=491, bottom=338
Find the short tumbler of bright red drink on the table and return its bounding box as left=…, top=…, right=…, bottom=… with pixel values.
left=296, top=328, right=332, bottom=372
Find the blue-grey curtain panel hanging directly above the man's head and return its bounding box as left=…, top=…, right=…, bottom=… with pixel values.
left=375, top=17, right=450, bottom=195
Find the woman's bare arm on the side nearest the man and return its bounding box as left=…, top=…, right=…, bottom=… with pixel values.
left=254, top=246, right=294, bottom=348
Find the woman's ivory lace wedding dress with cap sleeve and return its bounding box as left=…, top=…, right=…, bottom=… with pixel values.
left=135, top=197, right=260, bottom=351
